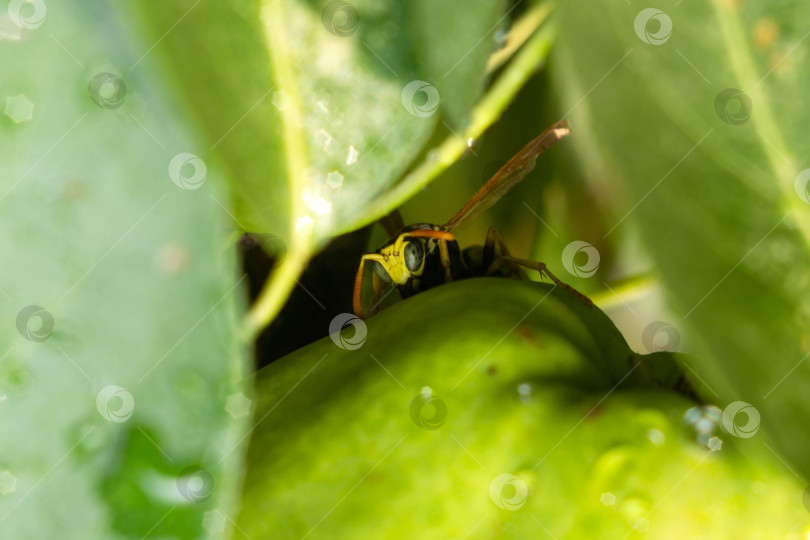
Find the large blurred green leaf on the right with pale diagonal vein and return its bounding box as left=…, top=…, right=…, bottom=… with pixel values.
left=553, top=0, right=810, bottom=477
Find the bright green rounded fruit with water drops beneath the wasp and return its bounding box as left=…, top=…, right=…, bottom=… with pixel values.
left=237, top=279, right=810, bottom=538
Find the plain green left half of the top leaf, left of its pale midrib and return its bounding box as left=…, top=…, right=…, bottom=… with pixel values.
left=128, top=0, right=288, bottom=236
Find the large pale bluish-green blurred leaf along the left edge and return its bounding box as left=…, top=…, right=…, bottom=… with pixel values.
left=0, top=2, right=250, bottom=538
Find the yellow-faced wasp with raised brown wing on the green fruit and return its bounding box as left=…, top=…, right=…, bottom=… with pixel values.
left=353, top=120, right=593, bottom=318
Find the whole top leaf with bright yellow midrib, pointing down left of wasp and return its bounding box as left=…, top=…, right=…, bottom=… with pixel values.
left=128, top=0, right=502, bottom=243
